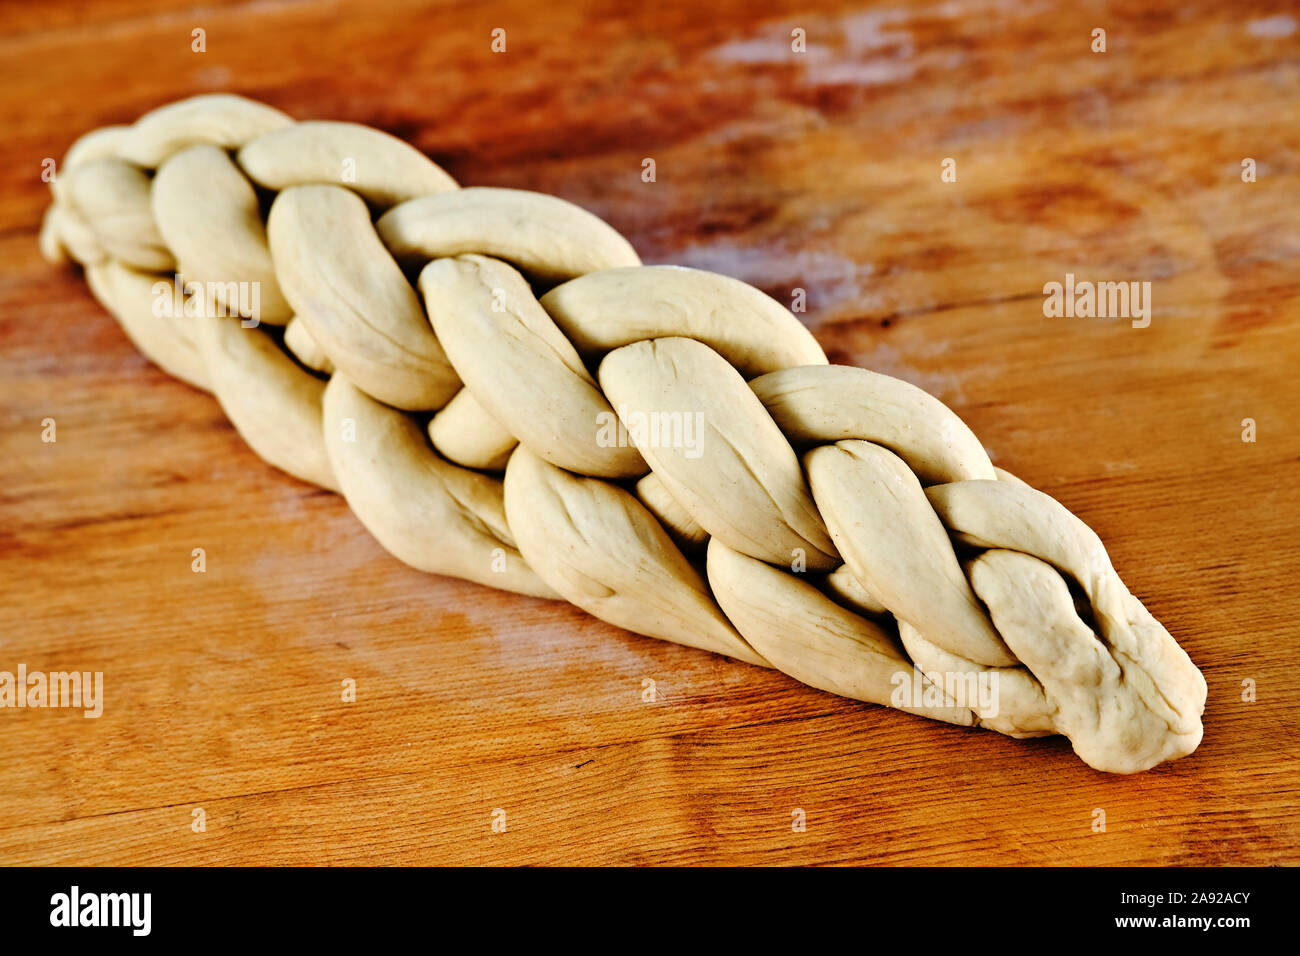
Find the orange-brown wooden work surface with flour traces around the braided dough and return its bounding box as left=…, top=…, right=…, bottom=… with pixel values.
left=0, top=0, right=1300, bottom=865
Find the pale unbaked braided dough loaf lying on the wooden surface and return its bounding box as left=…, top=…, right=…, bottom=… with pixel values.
left=40, top=95, right=1205, bottom=773
